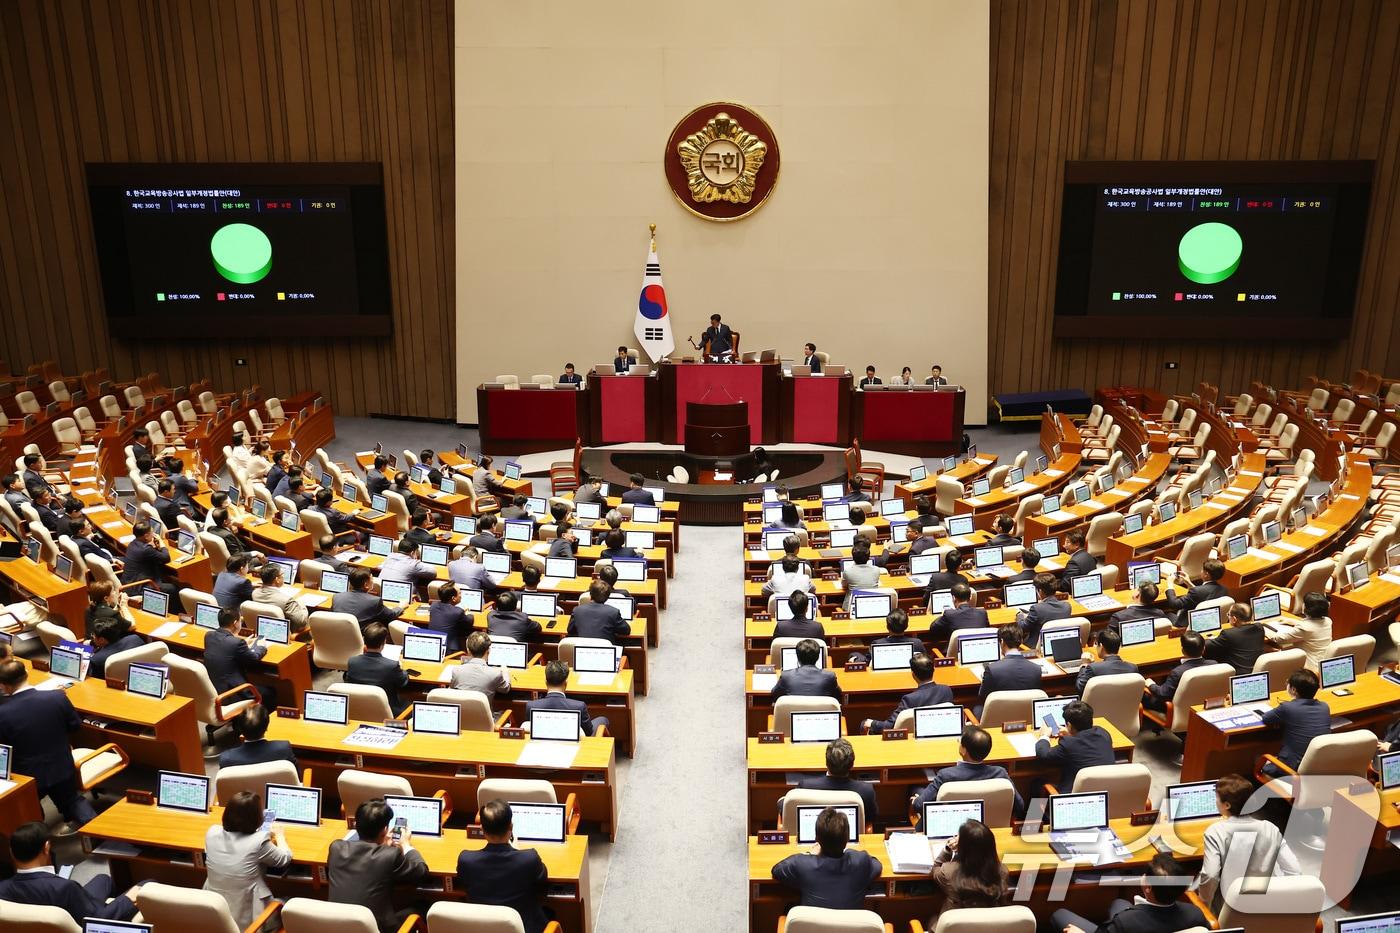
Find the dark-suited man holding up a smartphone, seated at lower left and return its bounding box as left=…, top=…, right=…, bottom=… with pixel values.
left=326, top=797, right=428, bottom=933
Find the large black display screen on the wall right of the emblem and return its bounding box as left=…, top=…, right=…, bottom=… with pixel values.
left=1056, top=163, right=1371, bottom=339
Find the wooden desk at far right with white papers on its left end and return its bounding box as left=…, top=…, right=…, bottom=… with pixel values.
left=1182, top=671, right=1400, bottom=782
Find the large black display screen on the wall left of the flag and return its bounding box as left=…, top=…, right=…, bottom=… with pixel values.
left=88, top=163, right=391, bottom=339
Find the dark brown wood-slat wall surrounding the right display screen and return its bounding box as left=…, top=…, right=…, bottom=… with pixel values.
left=988, top=0, right=1400, bottom=392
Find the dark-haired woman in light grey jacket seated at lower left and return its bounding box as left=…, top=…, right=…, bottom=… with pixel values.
left=204, top=790, right=291, bottom=930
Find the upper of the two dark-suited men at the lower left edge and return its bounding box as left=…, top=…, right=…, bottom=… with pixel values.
left=0, top=658, right=97, bottom=825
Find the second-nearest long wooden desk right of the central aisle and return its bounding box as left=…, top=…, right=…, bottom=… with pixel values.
left=748, top=714, right=1131, bottom=832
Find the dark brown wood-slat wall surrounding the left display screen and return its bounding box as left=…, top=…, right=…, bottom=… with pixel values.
left=0, top=0, right=454, bottom=417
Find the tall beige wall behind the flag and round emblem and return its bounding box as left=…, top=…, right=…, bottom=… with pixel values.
left=455, top=0, right=988, bottom=423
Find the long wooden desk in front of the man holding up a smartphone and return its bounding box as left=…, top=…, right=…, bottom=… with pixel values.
left=83, top=785, right=592, bottom=930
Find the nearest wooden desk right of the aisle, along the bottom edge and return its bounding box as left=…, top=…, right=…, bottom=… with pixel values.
left=749, top=820, right=1214, bottom=933
